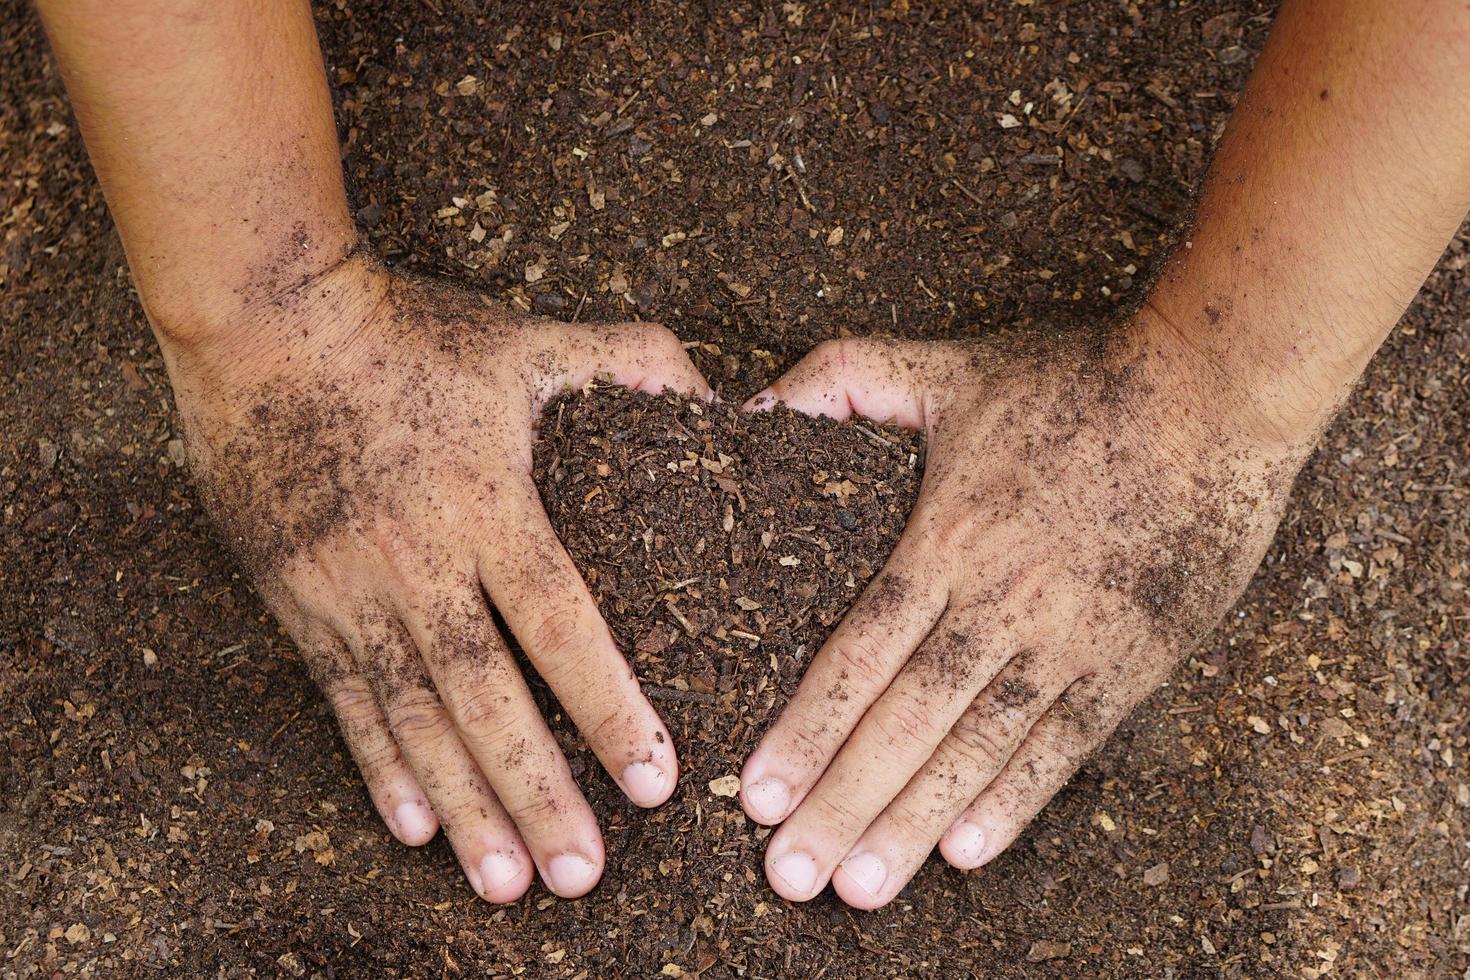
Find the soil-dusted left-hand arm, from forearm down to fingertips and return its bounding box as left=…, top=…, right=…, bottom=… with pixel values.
left=38, top=0, right=709, bottom=902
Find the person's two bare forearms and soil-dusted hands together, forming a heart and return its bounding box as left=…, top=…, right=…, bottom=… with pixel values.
left=38, top=0, right=1470, bottom=908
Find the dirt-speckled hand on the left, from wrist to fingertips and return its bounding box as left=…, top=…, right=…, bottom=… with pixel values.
left=168, top=257, right=710, bottom=902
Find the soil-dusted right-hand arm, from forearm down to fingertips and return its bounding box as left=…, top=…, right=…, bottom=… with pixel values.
left=742, top=0, right=1470, bottom=908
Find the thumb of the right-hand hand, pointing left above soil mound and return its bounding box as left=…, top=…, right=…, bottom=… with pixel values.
left=744, top=338, right=945, bottom=429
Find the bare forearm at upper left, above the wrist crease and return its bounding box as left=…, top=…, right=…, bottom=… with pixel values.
left=37, top=0, right=354, bottom=348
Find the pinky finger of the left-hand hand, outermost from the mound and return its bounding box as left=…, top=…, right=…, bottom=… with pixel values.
left=322, top=674, right=440, bottom=846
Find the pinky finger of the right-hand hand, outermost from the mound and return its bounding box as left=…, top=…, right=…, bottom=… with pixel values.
left=939, top=674, right=1122, bottom=871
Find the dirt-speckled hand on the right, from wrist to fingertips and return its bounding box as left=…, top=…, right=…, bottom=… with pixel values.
left=741, top=319, right=1305, bottom=908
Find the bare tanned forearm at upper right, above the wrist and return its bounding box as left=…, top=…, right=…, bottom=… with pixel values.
left=1139, top=0, right=1470, bottom=442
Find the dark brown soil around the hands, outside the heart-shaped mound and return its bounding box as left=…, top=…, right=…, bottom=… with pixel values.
left=0, top=0, right=1470, bottom=977
